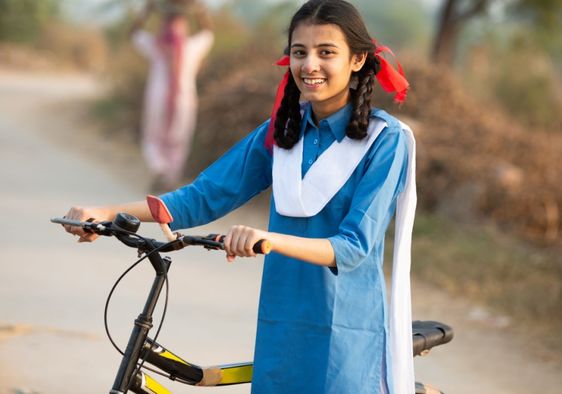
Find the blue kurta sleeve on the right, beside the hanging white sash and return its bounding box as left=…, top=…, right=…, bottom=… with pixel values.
left=329, top=127, right=408, bottom=272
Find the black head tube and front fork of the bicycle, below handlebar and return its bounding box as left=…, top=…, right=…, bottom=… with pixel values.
left=109, top=240, right=172, bottom=394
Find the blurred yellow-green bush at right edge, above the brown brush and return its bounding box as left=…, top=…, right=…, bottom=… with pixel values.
left=460, top=21, right=562, bottom=132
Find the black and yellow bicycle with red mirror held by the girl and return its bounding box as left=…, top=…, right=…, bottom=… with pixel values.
left=51, top=196, right=453, bottom=394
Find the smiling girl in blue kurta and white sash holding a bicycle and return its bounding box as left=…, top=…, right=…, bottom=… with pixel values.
left=67, top=0, right=415, bottom=394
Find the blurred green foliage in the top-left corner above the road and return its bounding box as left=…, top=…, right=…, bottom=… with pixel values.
left=0, top=0, right=60, bottom=44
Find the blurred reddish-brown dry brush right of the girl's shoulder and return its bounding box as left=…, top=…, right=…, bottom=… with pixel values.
left=388, top=62, right=562, bottom=244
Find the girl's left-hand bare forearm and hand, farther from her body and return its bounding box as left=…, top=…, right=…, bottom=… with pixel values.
left=64, top=201, right=154, bottom=242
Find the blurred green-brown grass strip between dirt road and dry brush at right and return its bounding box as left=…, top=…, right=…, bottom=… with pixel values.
left=394, top=213, right=562, bottom=350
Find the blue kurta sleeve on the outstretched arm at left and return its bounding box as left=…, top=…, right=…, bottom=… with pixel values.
left=161, top=122, right=272, bottom=230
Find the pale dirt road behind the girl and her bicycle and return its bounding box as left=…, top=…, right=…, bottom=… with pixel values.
left=0, top=70, right=562, bottom=394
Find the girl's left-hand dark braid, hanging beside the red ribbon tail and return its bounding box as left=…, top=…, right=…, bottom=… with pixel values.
left=273, top=73, right=301, bottom=149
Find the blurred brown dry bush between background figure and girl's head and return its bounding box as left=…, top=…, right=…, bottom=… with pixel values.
left=187, top=38, right=285, bottom=176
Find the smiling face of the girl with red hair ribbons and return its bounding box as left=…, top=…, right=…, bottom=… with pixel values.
left=290, top=23, right=366, bottom=121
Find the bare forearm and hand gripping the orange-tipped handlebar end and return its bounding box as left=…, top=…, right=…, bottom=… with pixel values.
left=224, top=226, right=336, bottom=267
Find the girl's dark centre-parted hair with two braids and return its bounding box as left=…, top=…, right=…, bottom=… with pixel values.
left=274, top=0, right=380, bottom=149
